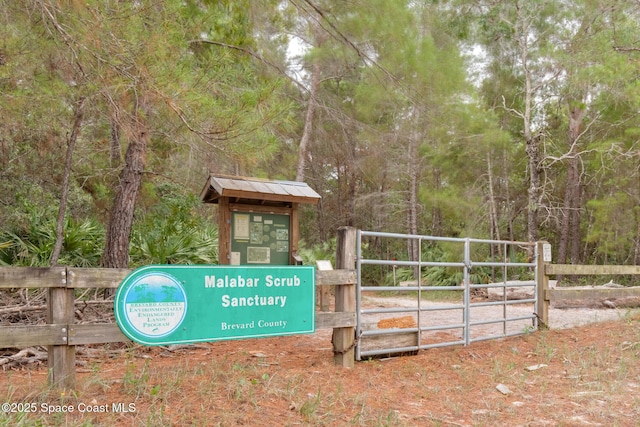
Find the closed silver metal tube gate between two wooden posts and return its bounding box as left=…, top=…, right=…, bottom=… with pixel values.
left=356, top=230, right=539, bottom=360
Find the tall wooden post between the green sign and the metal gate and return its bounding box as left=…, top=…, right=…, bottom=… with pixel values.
left=333, top=227, right=356, bottom=368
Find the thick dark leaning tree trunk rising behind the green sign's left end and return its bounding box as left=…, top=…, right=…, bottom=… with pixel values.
left=102, top=101, right=149, bottom=268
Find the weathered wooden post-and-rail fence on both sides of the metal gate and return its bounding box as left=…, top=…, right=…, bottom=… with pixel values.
left=0, top=237, right=640, bottom=389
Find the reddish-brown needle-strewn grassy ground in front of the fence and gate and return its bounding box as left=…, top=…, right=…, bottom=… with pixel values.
left=0, top=315, right=640, bottom=427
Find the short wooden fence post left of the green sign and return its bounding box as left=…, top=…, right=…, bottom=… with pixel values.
left=47, top=270, right=76, bottom=389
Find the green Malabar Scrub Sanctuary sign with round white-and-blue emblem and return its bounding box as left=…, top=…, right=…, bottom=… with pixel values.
left=114, top=265, right=315, bottom=345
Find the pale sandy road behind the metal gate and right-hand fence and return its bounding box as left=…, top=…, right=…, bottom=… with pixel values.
left=360, top=295, right=638, bottom=358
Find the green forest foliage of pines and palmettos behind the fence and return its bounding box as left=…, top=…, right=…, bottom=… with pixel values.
left=0, top=0, right=640, bottom=270
